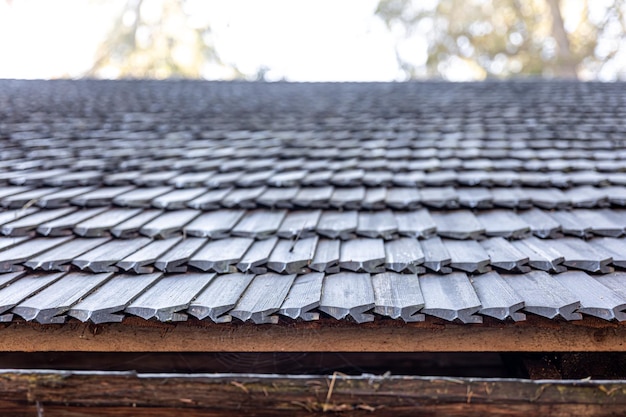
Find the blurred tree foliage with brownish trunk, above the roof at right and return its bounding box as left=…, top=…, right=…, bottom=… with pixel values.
left=376, top=0, right=626, bottom=80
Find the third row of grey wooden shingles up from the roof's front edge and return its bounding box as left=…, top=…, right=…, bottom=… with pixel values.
left=0, top=207, right=626, bottom=240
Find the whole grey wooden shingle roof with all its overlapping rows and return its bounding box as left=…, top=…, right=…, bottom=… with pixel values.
left=0, top=80, right=626, bottom=342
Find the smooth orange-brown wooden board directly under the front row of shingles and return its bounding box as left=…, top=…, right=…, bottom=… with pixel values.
left=0, top=318, right=626, bottom=352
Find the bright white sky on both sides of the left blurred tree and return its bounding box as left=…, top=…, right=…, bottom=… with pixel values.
left=0, top=0, right=402, bottom=81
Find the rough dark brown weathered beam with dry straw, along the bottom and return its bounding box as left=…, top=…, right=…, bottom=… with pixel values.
left=0, top=371, right=626, bottom=417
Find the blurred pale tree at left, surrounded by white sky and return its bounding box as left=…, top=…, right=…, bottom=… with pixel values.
left=86, top=0, right=241, bottom=79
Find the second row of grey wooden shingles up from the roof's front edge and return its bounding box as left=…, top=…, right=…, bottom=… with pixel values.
left=0, top=236, right=626, bottom=274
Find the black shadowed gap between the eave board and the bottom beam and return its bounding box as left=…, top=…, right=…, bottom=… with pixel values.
left=0, top=351, right=508, bottom=379
